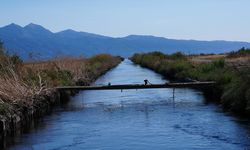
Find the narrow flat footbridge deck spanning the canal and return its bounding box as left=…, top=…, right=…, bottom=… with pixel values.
left=56, top=81, right=215, bottom=90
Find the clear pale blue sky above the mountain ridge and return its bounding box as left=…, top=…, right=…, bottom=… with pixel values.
left=0, top=0, right=250, bottom=42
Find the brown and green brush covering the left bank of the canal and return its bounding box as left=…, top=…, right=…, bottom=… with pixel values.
left=0, top=43, right=122, bottom=115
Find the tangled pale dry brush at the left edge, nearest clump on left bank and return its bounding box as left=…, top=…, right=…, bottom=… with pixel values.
left=0, top=56, right=46, bottom=103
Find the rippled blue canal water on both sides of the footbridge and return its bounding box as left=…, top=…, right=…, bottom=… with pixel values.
left=7, top=60, right=250, bottom=150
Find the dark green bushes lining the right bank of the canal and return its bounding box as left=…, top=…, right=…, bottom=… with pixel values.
left=131, top=50, right=250, bottom=114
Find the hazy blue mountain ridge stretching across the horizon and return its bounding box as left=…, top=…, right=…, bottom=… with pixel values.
left=0, top=23, right=250, bottom=59
